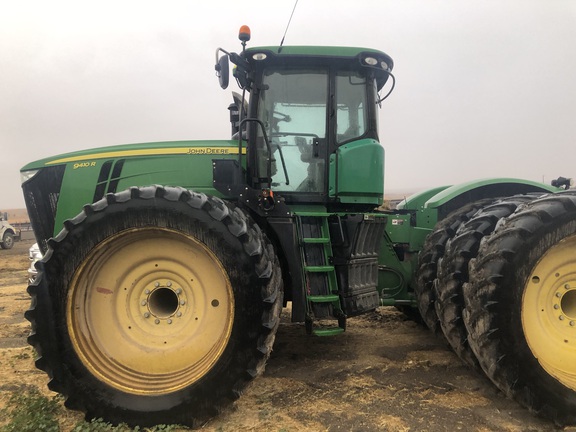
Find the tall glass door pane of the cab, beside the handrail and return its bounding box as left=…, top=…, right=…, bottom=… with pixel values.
left=257, top=69, right=328, bottom=193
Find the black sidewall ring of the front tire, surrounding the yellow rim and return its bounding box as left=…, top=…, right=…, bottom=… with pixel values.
left=45, top=195, right=274, bottom=425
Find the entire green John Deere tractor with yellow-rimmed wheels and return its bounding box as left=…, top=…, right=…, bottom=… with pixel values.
left=21, top=27, right=576, bottom=426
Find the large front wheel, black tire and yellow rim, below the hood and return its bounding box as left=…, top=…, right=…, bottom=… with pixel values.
left=26, top=187, right=282, bottom=427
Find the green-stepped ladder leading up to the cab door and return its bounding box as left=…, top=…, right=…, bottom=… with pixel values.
left=296, top=213, right=346, bottom=336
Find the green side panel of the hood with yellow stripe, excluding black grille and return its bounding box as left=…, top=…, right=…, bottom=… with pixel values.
left=35, top=141, right=243, bottom=235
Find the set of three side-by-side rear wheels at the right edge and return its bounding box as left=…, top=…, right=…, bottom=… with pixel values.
left=416, top=192, right=576, bottom=425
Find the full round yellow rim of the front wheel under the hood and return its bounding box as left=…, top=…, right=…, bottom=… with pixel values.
left=67, top=228, right=234, bottom=395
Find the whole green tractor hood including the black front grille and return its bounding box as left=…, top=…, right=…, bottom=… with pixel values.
left=21, top=140, right=245, bottom=246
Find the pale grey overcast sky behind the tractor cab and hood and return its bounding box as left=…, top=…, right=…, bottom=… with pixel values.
left=0, top=0, right=576, bottom=209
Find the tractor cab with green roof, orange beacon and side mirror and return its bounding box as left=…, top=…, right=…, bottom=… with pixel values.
left=216, top=28, right=392, bottom=209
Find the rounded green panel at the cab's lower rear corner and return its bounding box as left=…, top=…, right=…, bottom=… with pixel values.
left=328, top=139, right=384, bottom=206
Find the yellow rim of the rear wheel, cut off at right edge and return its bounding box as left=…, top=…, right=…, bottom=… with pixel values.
left=522, top=236, right=576, bottom=390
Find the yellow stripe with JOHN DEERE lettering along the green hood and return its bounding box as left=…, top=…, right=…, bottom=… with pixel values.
left=46, top=147, right=246, bottom=165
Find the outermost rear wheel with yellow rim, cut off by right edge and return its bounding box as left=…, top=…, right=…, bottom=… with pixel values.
left=463, top=193, right=576, bottom=425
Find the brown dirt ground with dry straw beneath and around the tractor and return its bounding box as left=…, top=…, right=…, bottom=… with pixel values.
left=0, top=241, right=576, bottom=432
